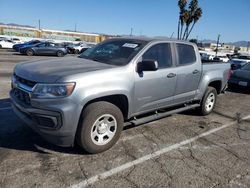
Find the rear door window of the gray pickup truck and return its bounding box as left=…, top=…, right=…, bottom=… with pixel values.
left=176, top=44, right=196, bottom=65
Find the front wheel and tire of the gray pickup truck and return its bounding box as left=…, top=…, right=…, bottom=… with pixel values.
left=76, top=101, right=124, bottom=154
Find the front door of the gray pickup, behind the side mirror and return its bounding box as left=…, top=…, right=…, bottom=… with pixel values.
left=134, top=43, right=176, bottom=113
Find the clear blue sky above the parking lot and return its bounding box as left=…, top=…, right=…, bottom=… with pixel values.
left=0, top=0, right=250, bottom=42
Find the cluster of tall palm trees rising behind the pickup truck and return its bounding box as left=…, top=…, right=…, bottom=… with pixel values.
left=177, top=0, right=202, bottom=40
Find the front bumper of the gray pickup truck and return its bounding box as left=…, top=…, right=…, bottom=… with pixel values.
left=10, top=89, right=79, bottom=147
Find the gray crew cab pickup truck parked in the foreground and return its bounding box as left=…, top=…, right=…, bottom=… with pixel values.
left=10, top=38, right=230, bottom=153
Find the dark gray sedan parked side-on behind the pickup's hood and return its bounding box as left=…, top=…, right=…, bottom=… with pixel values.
left=19, top=42, right=67, bottom=57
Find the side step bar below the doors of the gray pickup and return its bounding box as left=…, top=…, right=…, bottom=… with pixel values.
left=128, top=104, right=200, bottom=126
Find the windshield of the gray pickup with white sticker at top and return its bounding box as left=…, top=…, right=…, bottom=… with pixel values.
left=80, top=39, right=146, bottom=66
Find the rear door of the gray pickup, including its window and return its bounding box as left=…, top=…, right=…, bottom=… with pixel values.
left=174, top=43, right=201, bottom=104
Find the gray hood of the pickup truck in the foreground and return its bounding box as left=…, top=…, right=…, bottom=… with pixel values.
left=15, top=57, right=116, bottom=83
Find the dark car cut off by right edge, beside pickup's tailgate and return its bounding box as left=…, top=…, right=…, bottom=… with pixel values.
left=228, top=63, right=250, bottom=89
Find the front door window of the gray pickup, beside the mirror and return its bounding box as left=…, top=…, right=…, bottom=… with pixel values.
left=142, top=43, right=172, bottom=69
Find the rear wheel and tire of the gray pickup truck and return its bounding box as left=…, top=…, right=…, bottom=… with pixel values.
left=198, top=87, right=217, bottom=116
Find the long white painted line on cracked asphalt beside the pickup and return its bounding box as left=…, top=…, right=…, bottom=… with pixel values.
left=70, top=115, right=250, bottom=188
